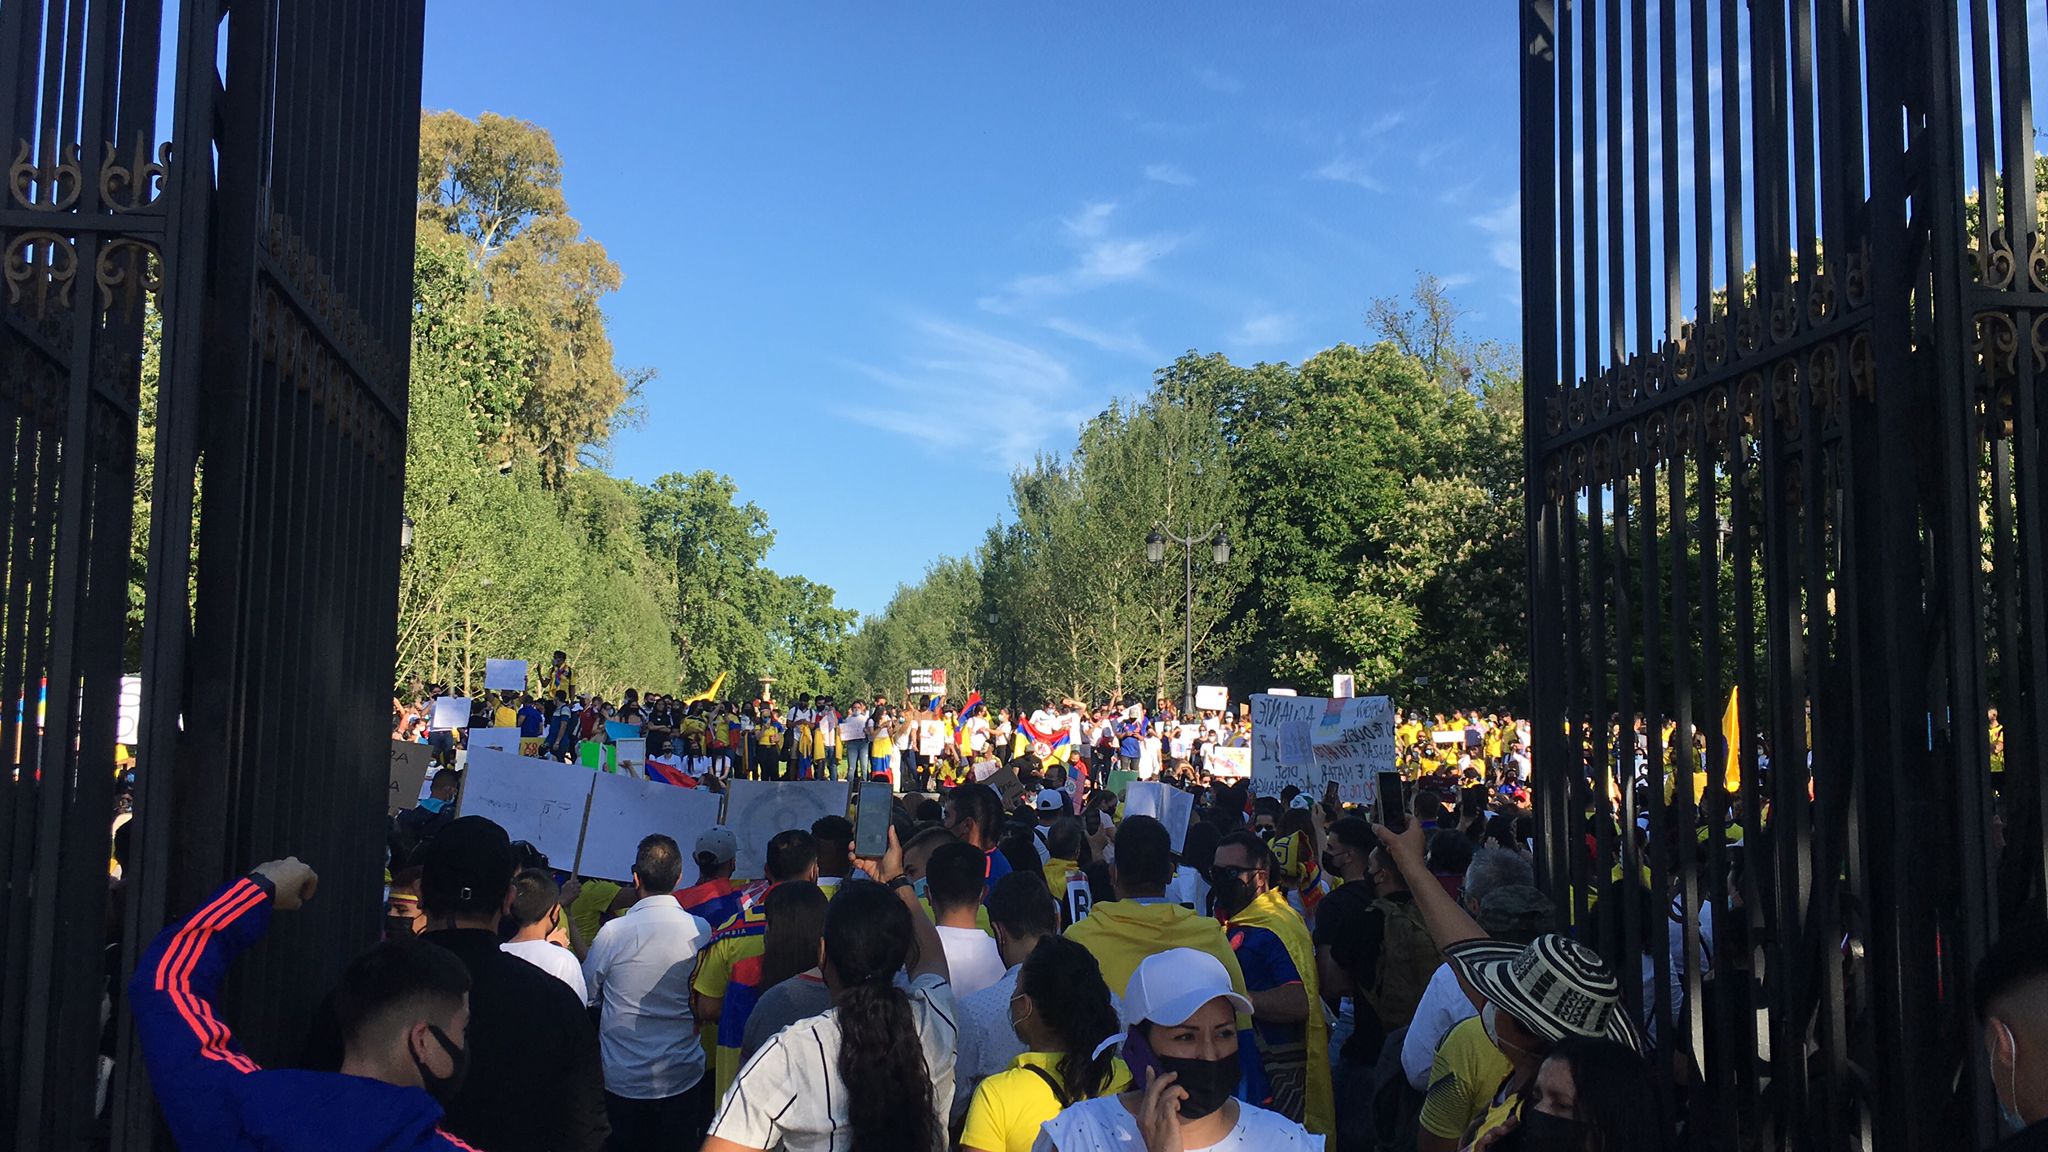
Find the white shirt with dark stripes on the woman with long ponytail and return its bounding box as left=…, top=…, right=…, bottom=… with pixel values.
left=711, top=972, right=958, bottom=1152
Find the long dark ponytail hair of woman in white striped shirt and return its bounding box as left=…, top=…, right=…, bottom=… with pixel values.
left=825, top=881, right=944, bottom=1152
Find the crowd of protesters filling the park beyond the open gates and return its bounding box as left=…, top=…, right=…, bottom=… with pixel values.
left=129, top=660, right=1884, bottom=1152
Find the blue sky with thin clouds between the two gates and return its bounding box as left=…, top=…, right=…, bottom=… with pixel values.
left=424, top=0, right=1520, bottom=611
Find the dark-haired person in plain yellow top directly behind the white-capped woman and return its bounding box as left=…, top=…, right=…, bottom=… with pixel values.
left=1067, top=816, right=1245, bottom=996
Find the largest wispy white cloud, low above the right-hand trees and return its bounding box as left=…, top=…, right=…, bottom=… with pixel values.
left=840, top=316, right=1090, bottom=469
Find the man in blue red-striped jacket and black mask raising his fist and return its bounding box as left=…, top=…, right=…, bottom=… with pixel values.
left=129, top=857, right=483, bottom=1152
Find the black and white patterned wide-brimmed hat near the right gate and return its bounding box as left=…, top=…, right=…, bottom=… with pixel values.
left=1444, top=935, right=1642, bottom=1052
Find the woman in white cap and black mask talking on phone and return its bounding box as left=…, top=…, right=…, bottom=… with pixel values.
left=1032, top=947, right=1323, bottom=1152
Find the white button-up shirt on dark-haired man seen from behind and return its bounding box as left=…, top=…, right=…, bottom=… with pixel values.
left=584, top=896, right=711, bottom=1101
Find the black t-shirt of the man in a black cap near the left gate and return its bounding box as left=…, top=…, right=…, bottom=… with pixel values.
left=420, top=929, right=610, bottom=1152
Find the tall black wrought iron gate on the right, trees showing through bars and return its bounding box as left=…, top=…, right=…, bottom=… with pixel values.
left=1518, top=0, right=2048, bottom=1150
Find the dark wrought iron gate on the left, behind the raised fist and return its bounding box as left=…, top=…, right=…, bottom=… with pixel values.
left=0, top=0, right=424, bottom=1148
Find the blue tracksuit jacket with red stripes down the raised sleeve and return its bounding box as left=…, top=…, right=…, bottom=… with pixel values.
left=129, top=875, right=473, bottom=1152
